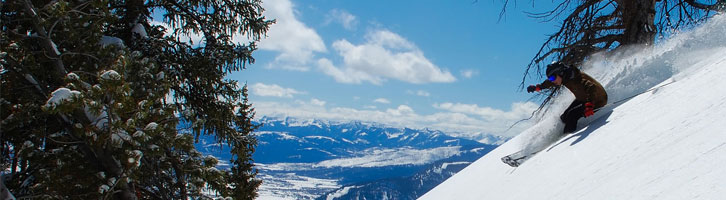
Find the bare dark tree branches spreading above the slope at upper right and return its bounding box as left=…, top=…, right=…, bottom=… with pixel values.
left=516, top=0, right=726, bottom=87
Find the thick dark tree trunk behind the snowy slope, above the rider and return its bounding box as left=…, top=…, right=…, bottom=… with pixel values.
left=618, top=0, right=656, bottom=45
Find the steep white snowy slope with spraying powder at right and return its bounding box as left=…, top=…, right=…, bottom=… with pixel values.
left=421, top=16, right=726, bottom=200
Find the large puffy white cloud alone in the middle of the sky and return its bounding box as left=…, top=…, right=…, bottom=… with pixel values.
left=318, top=30, right=456, bottom=85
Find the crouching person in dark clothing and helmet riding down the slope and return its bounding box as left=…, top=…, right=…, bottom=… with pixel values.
left=527, top=62, right=608, bottom=134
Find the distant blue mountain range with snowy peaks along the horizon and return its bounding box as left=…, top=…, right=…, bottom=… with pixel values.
left=254, top=118, right=492, bottom=167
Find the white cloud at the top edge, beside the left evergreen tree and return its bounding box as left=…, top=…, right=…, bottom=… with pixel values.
left=258, top=0, right=327, bottom=71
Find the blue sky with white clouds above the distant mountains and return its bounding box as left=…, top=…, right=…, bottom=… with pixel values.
left=233, top=0, right=557, bottom=137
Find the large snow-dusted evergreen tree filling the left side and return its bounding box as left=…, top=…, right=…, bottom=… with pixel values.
left=0, top=0, right=274, bottom=199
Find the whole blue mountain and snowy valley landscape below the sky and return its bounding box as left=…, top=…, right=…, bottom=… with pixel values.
left=193, top=117, right=503, bottom=199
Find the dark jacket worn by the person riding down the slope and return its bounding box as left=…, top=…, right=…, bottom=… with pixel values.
left=540, top=67, right=608, bottom=109
